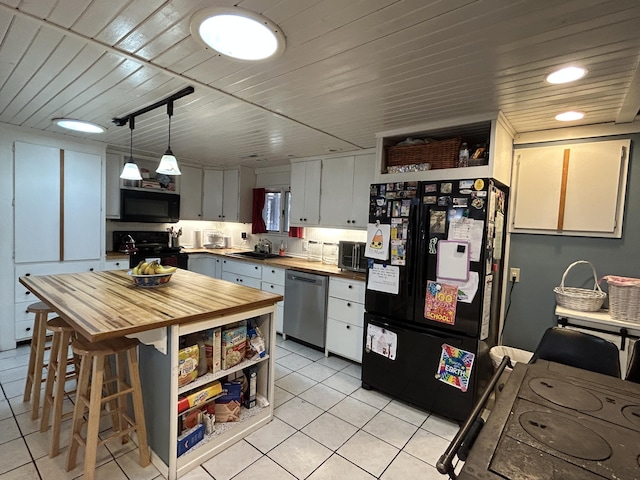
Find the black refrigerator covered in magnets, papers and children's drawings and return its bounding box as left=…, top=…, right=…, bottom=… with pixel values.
left=362, top=178, right=508, bottom=420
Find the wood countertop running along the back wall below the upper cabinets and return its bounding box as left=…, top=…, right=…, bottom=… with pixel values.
left=106, top=248, right=366, bottom=282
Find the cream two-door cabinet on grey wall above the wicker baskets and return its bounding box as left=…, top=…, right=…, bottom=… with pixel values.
left=512, top=140, right=630, bottom=238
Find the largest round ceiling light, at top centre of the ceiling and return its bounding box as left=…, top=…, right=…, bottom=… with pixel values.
left=190, top=7, right=286, bottom=61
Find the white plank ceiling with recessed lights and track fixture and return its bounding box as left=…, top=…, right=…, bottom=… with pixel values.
left=0, top=0, right=640, bottom=167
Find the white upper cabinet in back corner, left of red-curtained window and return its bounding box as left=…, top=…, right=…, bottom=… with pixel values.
left=202, top=167, right=255, bottom=223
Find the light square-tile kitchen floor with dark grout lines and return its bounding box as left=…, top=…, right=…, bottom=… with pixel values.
left=0, top=336, right=458, bottom=480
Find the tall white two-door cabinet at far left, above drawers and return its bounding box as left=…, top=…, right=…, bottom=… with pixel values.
left=14, top=142, right=103, bottom=263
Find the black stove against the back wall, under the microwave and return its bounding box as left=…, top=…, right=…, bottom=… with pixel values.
left=113, top=230, right=189, bottom=270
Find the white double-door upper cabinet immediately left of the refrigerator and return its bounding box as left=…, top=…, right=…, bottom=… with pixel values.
left=320, top=152, right=375, bottom=229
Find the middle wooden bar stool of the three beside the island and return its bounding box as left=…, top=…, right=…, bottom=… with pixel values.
left=40, top=317, right=79, bottom=457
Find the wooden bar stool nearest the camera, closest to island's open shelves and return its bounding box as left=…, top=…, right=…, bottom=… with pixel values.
left=67, top=337, right=150, bottom=480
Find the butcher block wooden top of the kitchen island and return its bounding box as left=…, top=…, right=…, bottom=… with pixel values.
left=20, top=269, right=283, bottom=342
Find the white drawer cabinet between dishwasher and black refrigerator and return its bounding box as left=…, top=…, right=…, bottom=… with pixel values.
left=325, top=277, right=365, bottom=363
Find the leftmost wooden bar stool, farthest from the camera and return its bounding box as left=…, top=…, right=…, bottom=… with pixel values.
left=23, top=302, right=53, bottom=420
